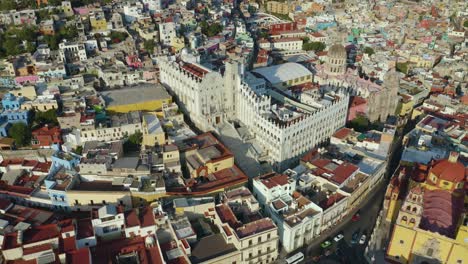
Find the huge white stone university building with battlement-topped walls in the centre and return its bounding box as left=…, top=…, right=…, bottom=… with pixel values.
left=158, top=55, right=349, bottom=169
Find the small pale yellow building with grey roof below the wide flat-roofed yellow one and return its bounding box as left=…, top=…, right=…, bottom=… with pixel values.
left=142, top=113, right=166, bottom=146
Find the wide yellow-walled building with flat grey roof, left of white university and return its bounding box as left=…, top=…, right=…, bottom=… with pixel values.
left=102, top=84, right=172, bottom=113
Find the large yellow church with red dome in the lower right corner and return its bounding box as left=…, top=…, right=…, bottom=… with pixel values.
left=387, top=152, right=468, bottom=263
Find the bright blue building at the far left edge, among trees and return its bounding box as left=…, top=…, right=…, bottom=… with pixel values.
left=0, top=93, right=29, bottom=125
